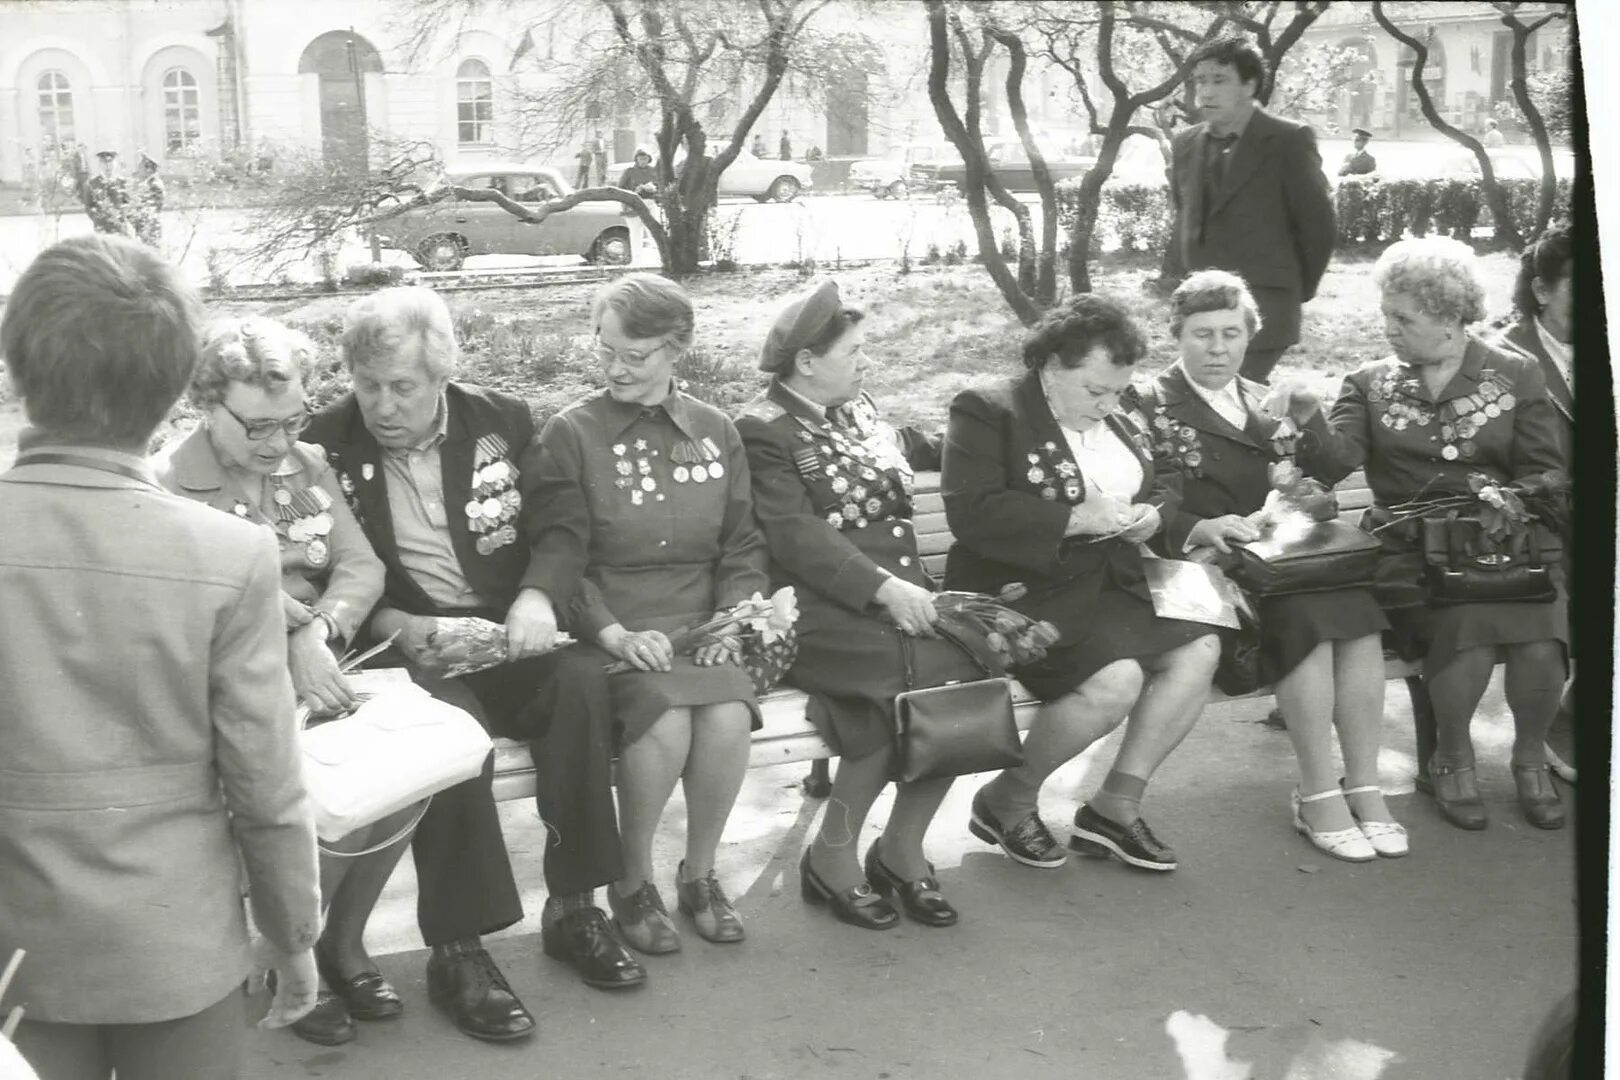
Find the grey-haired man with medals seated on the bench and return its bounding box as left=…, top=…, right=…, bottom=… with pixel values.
left=305, top=288, right=646, bottom=1040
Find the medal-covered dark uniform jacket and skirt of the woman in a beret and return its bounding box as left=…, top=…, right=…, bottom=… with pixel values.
left=737, top=379, right=1000, bottom=759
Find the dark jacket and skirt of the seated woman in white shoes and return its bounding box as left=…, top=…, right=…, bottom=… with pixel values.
left=1134, top=364, right=1390, bottom=683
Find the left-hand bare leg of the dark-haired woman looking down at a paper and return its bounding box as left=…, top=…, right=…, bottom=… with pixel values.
left=982, top=661, right=1142, bottom=823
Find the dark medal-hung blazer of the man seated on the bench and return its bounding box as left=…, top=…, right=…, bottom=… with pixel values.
left=303, top=382, right=585, bottom=622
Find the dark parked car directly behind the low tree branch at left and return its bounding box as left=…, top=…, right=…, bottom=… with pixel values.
left=377, top=162, right=640, bottom=270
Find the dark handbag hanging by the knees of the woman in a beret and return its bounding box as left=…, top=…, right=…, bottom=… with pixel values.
left=894, top=630, right=1024, bottom=784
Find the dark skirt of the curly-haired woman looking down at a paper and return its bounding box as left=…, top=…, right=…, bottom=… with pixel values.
left=1013, top=583, right=1217, bottom=701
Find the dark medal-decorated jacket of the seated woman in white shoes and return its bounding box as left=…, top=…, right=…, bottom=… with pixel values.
left=1132, top=364, right=1293, bottom=559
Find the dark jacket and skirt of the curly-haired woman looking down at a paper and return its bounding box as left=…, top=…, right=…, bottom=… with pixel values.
left=941, top=372, right=1215, bottom=701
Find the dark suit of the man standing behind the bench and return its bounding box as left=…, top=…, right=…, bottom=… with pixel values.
left=1170, top=107, right=1335, bottom=350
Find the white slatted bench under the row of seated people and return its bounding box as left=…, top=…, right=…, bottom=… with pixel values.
left=494, top=473, right=1421, bottom=800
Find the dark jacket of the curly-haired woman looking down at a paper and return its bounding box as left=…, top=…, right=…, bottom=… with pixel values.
left=940, top=372, right=1181, bottom=606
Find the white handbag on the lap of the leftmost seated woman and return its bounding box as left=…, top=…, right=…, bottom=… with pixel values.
left=300, top=669, right=494, bottom=855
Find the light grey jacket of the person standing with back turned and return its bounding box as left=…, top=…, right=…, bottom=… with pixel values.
left=0, top=442, right=319, bottom=1023
